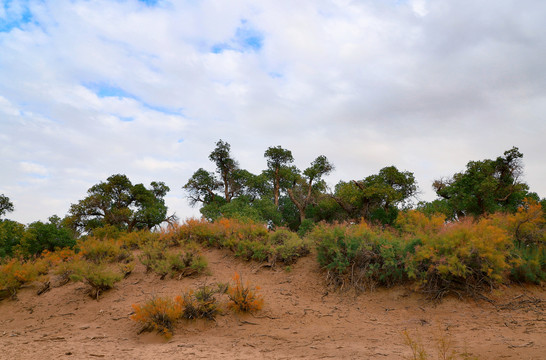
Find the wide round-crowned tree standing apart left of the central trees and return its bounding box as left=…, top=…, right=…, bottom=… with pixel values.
left=68, top=174, right=170, bottom=232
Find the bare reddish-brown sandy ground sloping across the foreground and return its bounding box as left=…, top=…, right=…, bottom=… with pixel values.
left=0, top=249, right=546, bottom=359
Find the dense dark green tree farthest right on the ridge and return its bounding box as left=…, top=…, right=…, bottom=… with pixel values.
left=432, top=147, right=529, bottom=218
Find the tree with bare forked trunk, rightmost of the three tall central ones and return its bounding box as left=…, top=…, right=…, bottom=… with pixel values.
left=287, top=155, right=334, bottom=222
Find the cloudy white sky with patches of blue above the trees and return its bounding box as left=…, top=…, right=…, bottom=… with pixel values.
left=0, top=0, right=546, bottom=224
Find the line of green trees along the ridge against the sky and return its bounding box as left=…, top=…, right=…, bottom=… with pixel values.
left=0, top=140, right=546, bottom=257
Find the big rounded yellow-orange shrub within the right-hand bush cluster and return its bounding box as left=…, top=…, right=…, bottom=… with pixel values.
left=409, top=219, right=512, bottom=299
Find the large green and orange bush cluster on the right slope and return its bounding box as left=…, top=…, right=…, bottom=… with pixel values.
left=308, top=200, right=546, bottom=299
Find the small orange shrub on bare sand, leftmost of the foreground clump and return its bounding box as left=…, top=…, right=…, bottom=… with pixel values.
left=131, top=298, right=183, bottom=339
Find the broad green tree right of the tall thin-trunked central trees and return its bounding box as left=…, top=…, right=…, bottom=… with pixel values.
left=331, top=166, right=417, bottom=224
